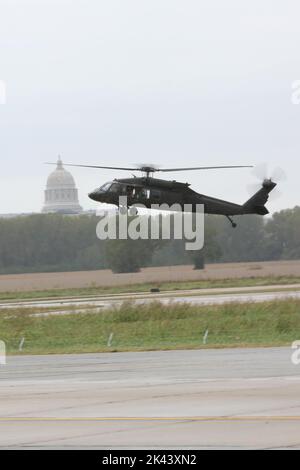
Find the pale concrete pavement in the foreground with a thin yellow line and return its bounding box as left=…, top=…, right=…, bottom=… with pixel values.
left=0, top=346, right=300, bottom=449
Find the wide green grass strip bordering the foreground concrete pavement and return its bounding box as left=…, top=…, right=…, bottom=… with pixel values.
left=0, top=300, right=300, bottom=354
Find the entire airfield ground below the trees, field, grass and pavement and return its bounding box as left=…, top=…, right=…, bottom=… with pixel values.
left=0, top=261, right=300, bottom=449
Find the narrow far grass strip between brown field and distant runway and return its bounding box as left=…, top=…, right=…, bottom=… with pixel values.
left=0, top=276, right=300, bottom=301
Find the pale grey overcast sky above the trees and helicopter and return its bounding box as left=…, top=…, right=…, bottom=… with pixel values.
left=0, top=0, right=300, bottom=213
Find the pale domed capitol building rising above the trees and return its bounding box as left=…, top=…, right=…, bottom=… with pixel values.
left=43, top=157, right=82, bottom=214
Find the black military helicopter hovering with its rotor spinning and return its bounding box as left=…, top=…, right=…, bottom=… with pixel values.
left=45, top=163, right=277, bottom=228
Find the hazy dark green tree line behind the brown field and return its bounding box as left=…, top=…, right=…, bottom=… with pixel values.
left=0, top=207, right=300, bottom=274
